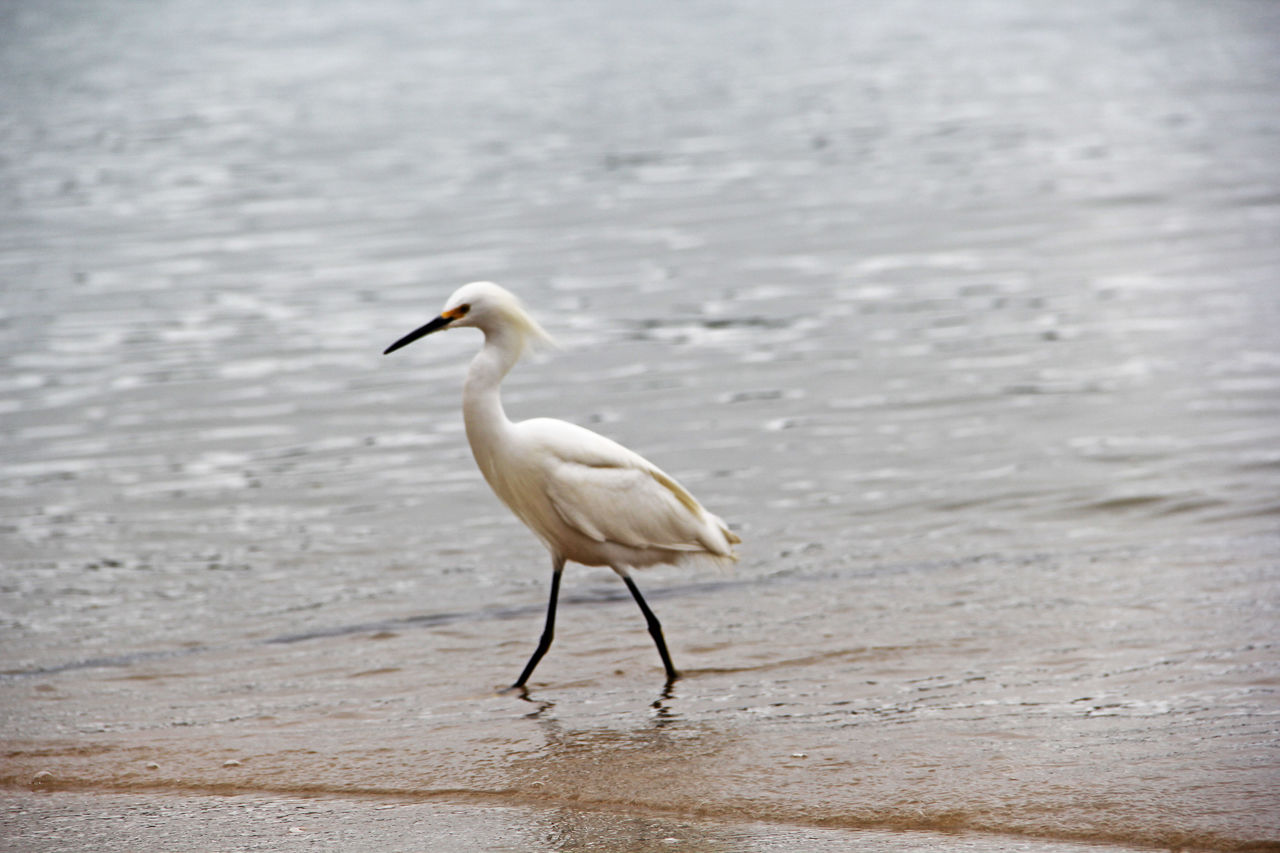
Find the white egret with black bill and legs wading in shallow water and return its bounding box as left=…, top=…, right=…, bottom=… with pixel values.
left=383, top=282, right=741, bottom=692
